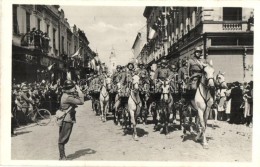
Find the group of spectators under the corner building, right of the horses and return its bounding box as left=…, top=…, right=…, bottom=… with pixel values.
left=213, top=81, right=253, bottom=127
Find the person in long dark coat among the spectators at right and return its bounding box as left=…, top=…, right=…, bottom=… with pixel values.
left=227, top=82, right=243, bottom=124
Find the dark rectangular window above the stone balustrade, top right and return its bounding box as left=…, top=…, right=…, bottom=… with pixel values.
left=223, top=8, right=242, bottom=21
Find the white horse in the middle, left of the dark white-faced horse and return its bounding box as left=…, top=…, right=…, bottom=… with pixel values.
left=128, top=75, right=142, bottom=140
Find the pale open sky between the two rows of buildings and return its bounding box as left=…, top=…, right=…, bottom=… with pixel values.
left=61, top=5, right=146, bottom=65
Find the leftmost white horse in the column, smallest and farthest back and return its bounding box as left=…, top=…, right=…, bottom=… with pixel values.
left=99, top=77, right=111, bottom=122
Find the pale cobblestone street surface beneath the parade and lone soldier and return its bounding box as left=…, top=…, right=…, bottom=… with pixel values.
left=11, top=101, right=252, bottom=162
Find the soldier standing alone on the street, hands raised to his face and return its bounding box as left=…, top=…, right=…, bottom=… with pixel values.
left=58, top=80, right=84, bottom=160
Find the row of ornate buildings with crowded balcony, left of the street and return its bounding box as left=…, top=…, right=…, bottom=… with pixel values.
left=12, top=5, right=99, bottom=82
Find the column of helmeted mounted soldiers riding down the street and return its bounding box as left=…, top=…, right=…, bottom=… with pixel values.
left=83, top=47, right=225, bottom=137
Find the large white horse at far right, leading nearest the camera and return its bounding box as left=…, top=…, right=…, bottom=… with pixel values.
left=191, top=61, right=215, bottom=149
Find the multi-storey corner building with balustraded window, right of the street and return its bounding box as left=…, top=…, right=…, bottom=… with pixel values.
left=144, top=7, right=254, bottom=82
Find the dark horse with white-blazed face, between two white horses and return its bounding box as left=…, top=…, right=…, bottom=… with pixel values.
left=161, top=80, right=173, bottom=135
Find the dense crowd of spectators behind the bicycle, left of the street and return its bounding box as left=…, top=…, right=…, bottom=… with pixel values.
left=11, top=80, right=62, bottom=135
